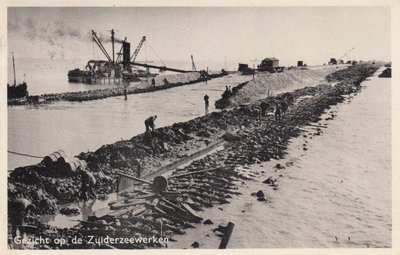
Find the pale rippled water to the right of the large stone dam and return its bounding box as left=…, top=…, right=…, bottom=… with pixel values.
left=170, top=68, right=392, bottom=248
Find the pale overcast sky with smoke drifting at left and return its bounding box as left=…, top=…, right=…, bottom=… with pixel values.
left=8, top=7, right=391, bottom=65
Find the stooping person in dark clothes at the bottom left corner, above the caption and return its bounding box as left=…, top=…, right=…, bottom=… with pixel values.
left=8, top=198, right=36, bottom=238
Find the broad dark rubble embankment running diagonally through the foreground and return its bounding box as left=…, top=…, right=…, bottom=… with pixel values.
left=8, top=65, right=378, bottom=248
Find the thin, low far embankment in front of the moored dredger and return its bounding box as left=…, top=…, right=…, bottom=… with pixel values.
left=8, top=71, right=228, bottom=105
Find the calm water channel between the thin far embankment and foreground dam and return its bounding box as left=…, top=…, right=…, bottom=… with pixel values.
left=8, top=74, right=252, bottom=169
